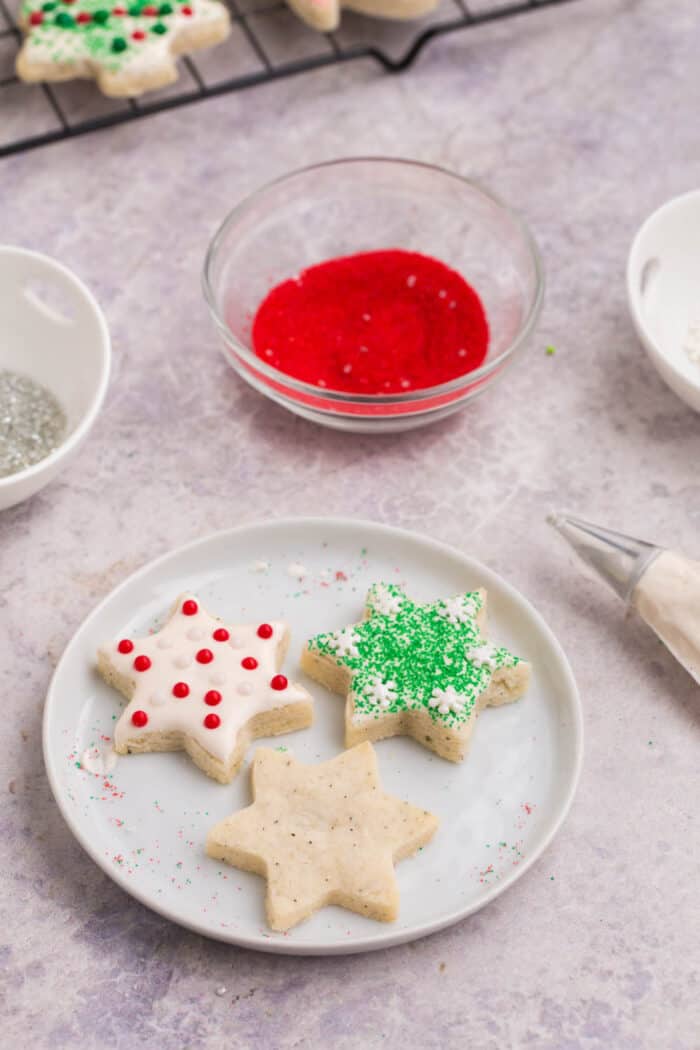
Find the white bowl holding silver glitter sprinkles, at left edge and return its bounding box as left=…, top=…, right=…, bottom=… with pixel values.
left=0, top=246, right=111, bottom=510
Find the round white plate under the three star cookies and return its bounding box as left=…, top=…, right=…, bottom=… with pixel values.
left=44, top=519, right=582, bottom=954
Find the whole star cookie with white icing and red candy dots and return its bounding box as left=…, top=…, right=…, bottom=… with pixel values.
left=98, top=594, right=313, bottom=783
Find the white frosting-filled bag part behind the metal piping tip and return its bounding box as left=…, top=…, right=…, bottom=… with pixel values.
left=632, top=550, right=700, bottom=684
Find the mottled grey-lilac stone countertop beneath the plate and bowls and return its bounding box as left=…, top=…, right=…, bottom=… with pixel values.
left=0, top=0, right=700, bottom=1050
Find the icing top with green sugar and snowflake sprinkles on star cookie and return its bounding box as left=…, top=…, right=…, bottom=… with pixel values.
left=309, top=584, right=521, bottom=726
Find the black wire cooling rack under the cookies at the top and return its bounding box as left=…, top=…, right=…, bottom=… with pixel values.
left=0, top=0, right=570, bottom=156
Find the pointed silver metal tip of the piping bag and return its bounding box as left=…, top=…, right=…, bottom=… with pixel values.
left=547, top=511, right=663, bottom=602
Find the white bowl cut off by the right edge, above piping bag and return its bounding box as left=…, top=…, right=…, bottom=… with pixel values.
left=628, top=190, right=700, bottom=412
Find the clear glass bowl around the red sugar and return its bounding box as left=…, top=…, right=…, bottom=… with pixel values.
left=203, top=158, right=544, bottom=433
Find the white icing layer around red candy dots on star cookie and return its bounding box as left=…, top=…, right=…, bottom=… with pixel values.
left=100, top=594, right=309, bottom=763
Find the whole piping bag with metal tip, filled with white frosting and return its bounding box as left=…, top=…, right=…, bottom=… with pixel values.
left=547, top=513, right=700, bottom=684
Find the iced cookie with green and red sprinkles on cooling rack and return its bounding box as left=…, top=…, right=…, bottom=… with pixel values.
left=17, top=0, right=230, bottom=97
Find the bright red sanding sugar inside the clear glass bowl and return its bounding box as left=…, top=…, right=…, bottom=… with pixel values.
left=253, top=249, right=489, bottom=394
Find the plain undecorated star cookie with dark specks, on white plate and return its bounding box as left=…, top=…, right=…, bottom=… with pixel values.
left=207, top=743, right=438, bottom=930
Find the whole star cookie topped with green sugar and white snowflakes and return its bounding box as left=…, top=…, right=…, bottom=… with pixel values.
left=301, top=584, right=530, bottom=762
